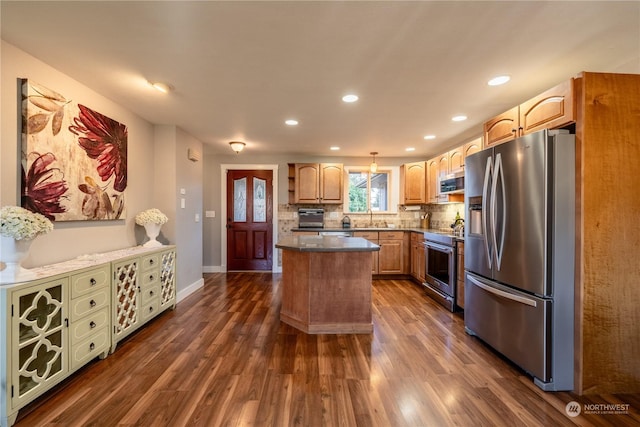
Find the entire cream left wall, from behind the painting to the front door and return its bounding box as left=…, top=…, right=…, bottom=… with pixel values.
left=0, top=41, right=202, bottom=299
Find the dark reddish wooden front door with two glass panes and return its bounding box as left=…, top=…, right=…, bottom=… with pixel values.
left=227, top=170, right=273, bottom=271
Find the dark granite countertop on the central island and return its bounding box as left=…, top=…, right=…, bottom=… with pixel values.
left=276, top=236, right=380, bottom=252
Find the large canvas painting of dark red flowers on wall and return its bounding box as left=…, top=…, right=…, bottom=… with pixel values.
left=22, top=79, right=127, bottom=221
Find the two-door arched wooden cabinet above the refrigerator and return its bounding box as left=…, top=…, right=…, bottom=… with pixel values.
left=484, top=79, right=576, bottom=147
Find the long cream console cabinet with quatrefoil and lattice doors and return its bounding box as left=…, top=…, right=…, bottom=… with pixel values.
left=0, top=246, right=176, bottom=427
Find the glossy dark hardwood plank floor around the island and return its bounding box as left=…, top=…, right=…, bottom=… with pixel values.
left=16, top=273, right=640, bottom=427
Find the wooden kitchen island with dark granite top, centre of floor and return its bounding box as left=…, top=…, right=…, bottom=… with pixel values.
left=276, top=236, right=380, bottom=334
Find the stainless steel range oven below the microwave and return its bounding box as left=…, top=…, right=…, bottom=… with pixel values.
left=424, top=233, right=457, bottom=311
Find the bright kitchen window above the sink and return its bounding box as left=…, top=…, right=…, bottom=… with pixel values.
left=345, top=167, right=397, bottom=213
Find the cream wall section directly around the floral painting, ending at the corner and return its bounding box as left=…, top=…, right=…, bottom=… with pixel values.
left=0, top=41, right=153, bottom=267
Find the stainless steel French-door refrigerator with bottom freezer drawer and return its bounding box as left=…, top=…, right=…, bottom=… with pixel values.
left=464, top=130, right=575, bottom=391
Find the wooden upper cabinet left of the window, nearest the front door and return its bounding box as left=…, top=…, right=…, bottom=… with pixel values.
left=289, top=163, right=343, bottom=204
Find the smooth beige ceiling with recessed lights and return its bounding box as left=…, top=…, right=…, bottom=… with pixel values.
left=0, top=0, right=640, bottom=158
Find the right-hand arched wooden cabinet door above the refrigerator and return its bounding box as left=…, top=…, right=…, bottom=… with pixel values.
left=520, top=79, right=575, bottom=135
